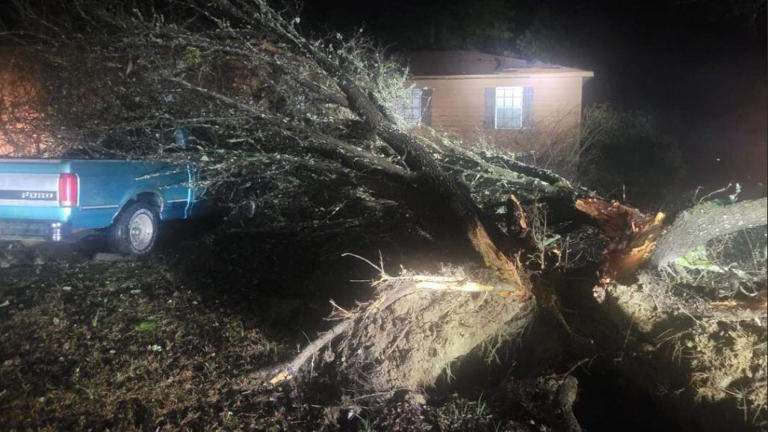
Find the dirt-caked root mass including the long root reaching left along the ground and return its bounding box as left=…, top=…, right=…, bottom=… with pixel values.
left=253, top=267, right=535, bottom=391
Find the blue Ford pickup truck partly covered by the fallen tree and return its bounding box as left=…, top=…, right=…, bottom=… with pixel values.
left=0, top=159, right=204, bottom=255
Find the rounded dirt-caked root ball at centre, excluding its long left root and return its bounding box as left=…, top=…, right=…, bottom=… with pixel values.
left=341, top=268, right=535, bottom=391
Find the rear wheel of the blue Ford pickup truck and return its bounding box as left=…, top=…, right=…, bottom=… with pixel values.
left=109, top=202, right=160, bottom=255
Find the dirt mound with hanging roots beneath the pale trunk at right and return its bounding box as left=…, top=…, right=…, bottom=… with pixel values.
left=606, top=272, right=768, bottom=430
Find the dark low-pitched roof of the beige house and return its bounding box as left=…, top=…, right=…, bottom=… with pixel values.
left=404, top=50, right=594, bottom=78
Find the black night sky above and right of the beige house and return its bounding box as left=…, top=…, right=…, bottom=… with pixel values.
left=302, top=0, right=768, bottom=187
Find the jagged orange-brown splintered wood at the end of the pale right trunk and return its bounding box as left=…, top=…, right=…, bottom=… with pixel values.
left=576, top=198, right=664, bottom=286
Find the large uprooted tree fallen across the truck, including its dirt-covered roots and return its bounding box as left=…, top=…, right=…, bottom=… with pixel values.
left=1, top=0, right=765, bottom=428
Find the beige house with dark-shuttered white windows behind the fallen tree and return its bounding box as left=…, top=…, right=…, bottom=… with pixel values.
left=401, top=51, right=594, bottom=155
